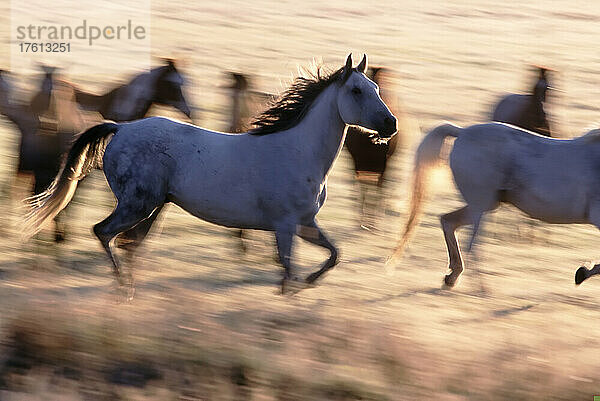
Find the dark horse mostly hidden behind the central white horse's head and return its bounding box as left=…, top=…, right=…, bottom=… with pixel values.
left=345, top=67, right=400, bottom=229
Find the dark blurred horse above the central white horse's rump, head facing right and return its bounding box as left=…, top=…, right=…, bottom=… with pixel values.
left=74, top=59, right=192, bottom=122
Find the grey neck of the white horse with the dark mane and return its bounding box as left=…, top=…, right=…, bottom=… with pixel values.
left=296, top=84, right=346, bottom=177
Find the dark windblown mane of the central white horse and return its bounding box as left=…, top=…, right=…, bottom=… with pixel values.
left=249, top=67, right=350, bottom=135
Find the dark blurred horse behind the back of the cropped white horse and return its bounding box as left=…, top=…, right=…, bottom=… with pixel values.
left=492, top=67, right=552, bottom=137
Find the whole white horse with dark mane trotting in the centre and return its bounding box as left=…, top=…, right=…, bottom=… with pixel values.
left=25, top=55, right=396, bottom=291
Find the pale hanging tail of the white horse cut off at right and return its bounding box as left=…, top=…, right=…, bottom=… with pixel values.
left=386, top=124, right=462, bottom=264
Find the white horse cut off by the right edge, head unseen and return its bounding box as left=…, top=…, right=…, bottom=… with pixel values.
left=387, top=123, right=600, bottom=287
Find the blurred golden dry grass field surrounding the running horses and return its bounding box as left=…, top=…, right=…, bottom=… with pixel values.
left=0, top=0, right=600, bottom=400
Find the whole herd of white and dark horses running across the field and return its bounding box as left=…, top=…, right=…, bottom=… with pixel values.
left=0, top=55, right=600, bottom=294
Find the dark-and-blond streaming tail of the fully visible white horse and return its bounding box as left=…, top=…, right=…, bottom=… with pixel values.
left=22, top=123, right=119, bottom=239
